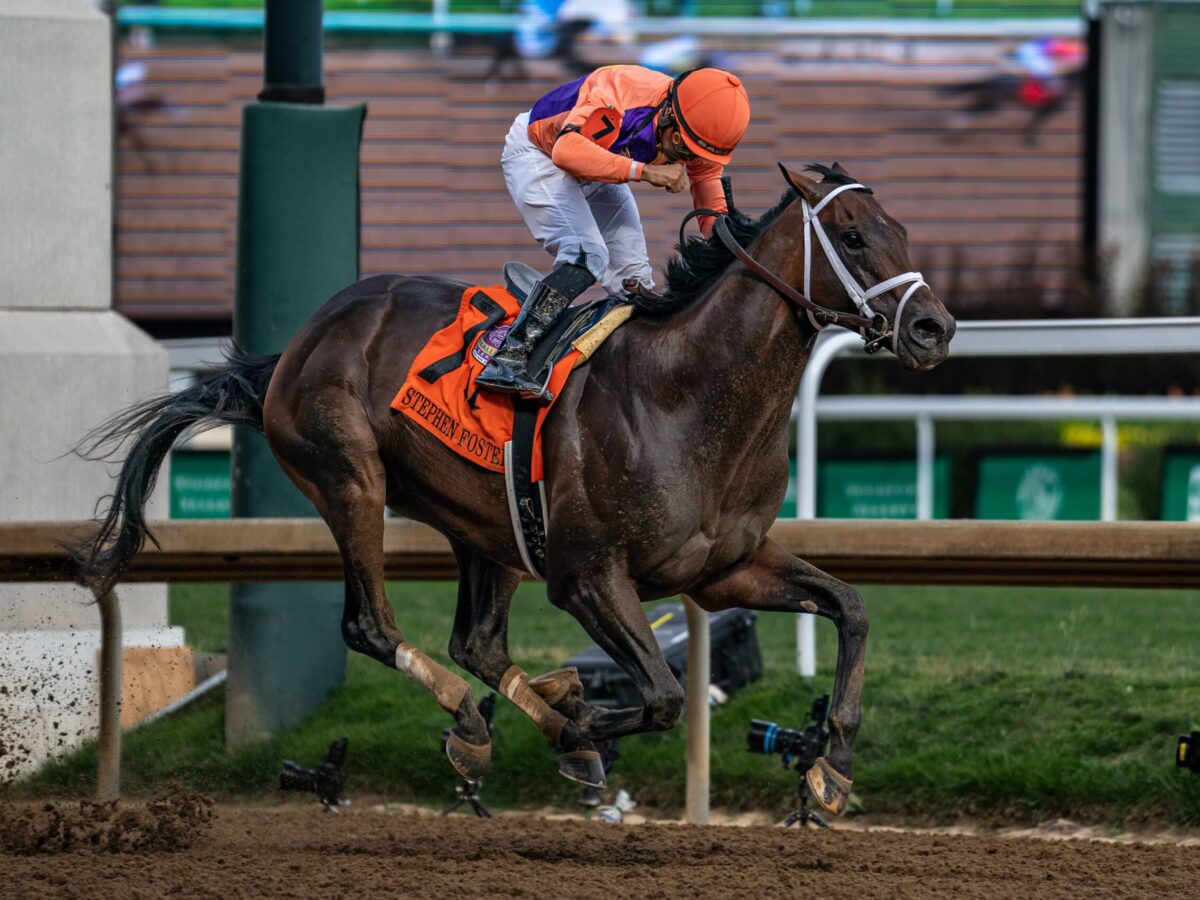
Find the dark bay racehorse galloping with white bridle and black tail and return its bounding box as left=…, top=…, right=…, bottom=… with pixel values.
left=78, top=164, right=954, bottom=812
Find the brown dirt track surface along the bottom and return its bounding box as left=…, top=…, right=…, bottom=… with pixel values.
left=0, top=804, right=1200, bottom=900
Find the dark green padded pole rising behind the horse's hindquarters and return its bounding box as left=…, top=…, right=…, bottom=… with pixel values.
left=226, top=0, right=366, bottom=748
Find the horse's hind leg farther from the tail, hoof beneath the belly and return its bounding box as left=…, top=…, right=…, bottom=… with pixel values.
left=450, top=540, right=605, bottom=787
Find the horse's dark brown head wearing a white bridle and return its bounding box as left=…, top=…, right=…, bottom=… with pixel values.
left=780, top=163, right=955, bottom=370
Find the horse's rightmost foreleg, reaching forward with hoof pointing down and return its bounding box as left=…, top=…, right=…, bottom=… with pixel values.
left=689, top=540, right=868, bottom=815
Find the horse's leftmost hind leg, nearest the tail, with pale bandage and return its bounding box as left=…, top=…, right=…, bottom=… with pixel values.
left=269, top=389, right=492, bottom=780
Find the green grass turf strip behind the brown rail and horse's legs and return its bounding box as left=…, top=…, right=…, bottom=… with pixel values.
left=18, top=583, right=1200, bottom=824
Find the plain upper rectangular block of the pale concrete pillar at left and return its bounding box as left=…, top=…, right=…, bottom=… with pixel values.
left=0, top=0, right=112, bottom=310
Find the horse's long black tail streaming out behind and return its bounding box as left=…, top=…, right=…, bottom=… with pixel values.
left=64, top=347, right=280, bottom=596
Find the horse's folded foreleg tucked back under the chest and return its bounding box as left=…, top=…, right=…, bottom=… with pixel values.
left=547, top=571, right=683, bottom=740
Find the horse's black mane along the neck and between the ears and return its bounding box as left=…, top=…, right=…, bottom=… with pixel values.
left=631, top=163, right=854, bottom=317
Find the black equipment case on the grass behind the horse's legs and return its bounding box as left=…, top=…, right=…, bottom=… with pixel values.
left=564, top=604, right=762, bottom=708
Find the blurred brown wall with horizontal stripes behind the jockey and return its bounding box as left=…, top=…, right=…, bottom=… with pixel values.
left=116, top=36, right=1081, bottom=323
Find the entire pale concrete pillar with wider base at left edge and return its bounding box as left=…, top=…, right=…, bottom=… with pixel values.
left=0, top=0, right=181, bottom=780
